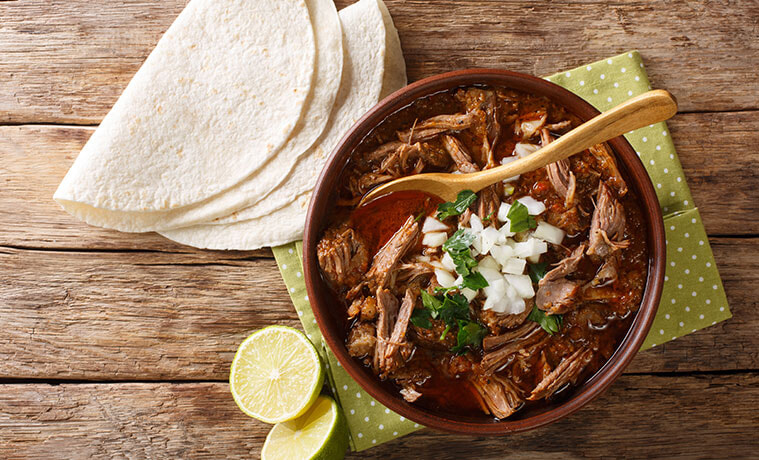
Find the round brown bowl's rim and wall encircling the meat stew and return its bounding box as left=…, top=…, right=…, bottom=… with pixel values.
left=303, top=69, right=666, bottom=435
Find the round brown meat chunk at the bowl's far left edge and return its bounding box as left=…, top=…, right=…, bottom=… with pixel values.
left=316, top=224, right=369, bottom=286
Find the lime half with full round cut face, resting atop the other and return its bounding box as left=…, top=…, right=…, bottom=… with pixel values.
left=229, top=326, right=324, bottom=423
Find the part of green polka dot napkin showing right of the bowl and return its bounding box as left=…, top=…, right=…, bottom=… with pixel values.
left=548, top=51, right=731, bottom=349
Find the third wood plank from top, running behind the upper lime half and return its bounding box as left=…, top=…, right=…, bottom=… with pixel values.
left=0, top=238, right=759, bottom=380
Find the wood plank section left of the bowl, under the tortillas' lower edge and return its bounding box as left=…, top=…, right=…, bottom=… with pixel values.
left=0, top=125, right=271, bottom=257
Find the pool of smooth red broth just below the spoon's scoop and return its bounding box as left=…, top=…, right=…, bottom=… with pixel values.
left=350, top=191, right=443, bottom=254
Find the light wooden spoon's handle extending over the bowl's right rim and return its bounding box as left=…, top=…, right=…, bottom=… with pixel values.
left=461, top=89, right=677, bottom=192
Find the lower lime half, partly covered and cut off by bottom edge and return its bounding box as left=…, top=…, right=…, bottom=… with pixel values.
left=261, top=396, right=348, bottom=460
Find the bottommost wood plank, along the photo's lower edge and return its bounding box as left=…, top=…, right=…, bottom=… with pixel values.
left=0, top=374, right=759, bottom=460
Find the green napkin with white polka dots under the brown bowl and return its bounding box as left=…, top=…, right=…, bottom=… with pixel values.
left=273, top=51, right=731, bottom=451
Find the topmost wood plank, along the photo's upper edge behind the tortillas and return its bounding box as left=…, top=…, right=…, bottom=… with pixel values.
left=0, top=0, right=759, bottom=124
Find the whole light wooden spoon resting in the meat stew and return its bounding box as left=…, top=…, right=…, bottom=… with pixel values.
left=359, top=89, right=677, bottom=206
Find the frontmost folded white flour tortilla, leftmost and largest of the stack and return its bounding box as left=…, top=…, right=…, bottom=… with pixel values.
left=54, top=0, right=316, bottom=231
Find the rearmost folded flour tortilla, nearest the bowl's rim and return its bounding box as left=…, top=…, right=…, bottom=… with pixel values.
left=160, top=0, right=406, bottom=250
